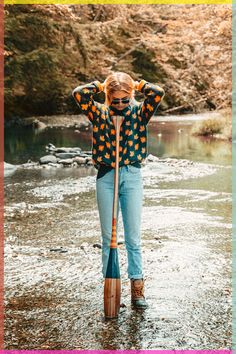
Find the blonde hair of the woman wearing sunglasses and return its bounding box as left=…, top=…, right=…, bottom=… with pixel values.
left=104, top=72, right=135, bottom=106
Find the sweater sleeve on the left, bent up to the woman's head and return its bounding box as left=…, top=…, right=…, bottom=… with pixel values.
left=72, top=81, right=102, bottom=123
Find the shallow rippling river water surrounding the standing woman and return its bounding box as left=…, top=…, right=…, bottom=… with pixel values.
left=5, top=113, right=232, bottom=350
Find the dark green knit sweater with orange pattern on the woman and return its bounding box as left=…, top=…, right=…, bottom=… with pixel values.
left=73, top=80, right=164, bottom=168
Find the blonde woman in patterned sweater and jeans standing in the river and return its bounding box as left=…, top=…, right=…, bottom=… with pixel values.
left=73, top=72, right=164, bottom=308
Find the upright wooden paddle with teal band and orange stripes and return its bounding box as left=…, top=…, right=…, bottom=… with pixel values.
left=104, top=116, right=124, bottom=318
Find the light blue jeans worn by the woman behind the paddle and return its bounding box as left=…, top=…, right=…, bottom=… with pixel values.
left=96, top=165, right=143, bottom=279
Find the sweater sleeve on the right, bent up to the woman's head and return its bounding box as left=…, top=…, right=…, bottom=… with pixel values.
left=137, top=80, right=165, bottom=124
